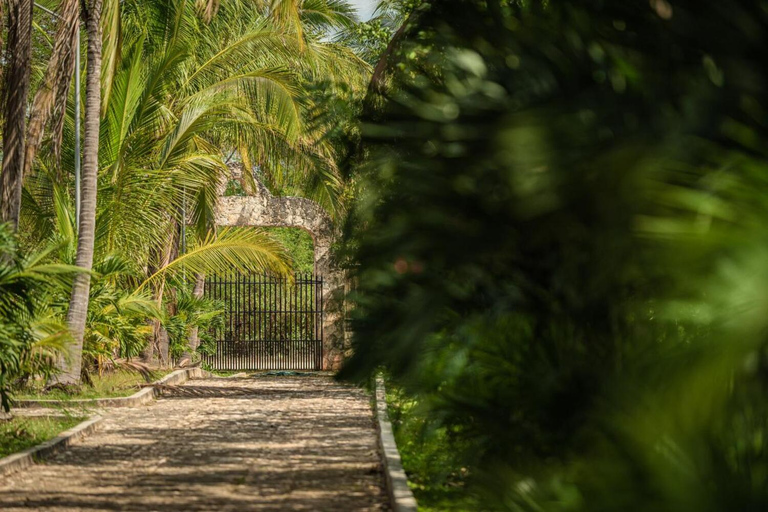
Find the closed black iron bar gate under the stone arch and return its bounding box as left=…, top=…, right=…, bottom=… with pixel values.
left=202, top=273, right=323, bottom=370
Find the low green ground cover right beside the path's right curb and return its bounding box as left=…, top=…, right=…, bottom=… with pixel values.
left=387, top=385, right=477, bottom=512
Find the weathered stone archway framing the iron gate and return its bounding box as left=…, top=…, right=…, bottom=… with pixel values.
left=215, top=174, right=345, bottom=370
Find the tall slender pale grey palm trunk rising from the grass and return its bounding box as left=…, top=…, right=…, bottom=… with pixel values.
left=59, top=0, right=102, bottom=383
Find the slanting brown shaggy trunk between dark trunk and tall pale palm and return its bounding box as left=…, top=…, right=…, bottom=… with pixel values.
left=24, top=0, right=80, bottom=176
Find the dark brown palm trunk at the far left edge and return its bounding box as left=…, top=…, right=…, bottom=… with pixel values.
left=0, top=0, right=34, bottom=228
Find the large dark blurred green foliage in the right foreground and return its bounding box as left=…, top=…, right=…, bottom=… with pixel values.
left=342, top=0, right=768, bottom=511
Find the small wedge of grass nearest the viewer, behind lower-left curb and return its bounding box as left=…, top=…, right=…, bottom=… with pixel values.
left=0, top=416, right=84, bottom=457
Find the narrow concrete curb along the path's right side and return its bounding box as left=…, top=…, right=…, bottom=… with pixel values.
left=376, top=376, right=418, bottom=512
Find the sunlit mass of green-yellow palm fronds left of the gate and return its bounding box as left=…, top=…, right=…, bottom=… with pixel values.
left=0, top=0, right=369, bottom=407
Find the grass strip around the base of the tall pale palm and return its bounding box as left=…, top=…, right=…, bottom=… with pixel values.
left=14, top=370, right=172, bottom=400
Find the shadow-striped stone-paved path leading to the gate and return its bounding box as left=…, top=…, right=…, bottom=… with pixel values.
left=0, top=376, right=388, bottom=512
